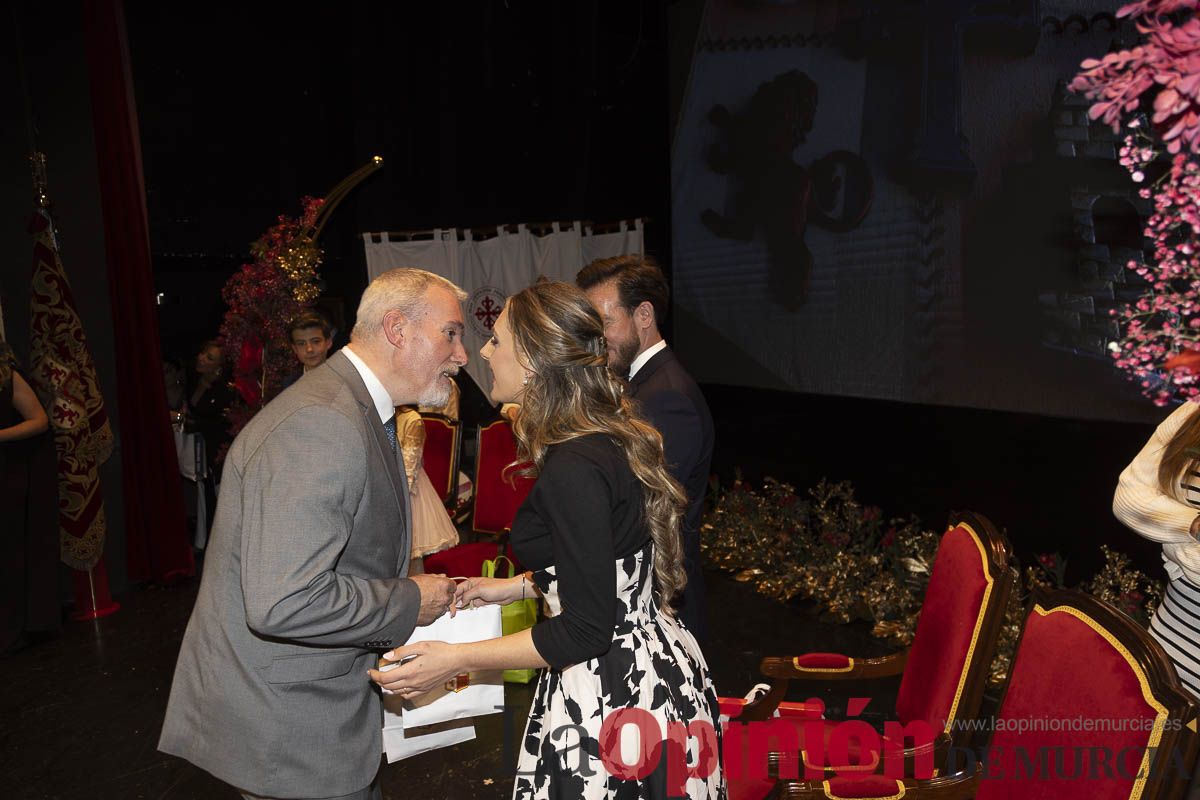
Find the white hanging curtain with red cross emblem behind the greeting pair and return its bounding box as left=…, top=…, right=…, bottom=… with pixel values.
left=362, top=219, right=643, bottom=395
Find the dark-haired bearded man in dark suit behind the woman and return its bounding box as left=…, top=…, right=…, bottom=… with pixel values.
left=575, top=255, right=714, bottom=644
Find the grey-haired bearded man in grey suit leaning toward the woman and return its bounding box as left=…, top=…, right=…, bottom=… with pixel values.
left=158, top=269, right=467, bottom=799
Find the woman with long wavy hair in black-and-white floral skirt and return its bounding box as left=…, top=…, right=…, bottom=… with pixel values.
left=372, top=281, right=725, bottom=798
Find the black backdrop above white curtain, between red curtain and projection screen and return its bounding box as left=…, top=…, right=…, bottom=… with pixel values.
left=127, top=1, right=668, bottom=367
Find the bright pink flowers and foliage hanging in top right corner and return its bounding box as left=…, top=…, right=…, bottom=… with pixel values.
left=1070, top=0, right=1200, bottom=405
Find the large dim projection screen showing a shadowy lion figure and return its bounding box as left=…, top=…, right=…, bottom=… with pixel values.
left=671, top=0, right=1158, bottom=422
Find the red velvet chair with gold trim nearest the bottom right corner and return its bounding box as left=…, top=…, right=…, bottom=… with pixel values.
left=775, top=590, right=1198, bottom=800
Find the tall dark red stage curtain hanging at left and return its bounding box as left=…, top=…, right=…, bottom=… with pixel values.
left=83, top=0, right=196, bottom=583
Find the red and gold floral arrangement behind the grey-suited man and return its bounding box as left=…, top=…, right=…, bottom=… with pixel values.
left=221, top=197, right=325, bottom=435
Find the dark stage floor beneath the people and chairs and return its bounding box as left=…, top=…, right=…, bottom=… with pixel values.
left=0, top=572, right=895, bottom=800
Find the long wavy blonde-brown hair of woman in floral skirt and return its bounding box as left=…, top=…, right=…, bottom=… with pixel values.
left=508, top=279, right=688, bottom=613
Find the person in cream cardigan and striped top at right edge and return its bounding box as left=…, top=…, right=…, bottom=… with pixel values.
left=1112, top=402, right=1200, bottom=697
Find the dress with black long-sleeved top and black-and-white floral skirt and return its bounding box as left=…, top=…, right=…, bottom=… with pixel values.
left=512, top=434, right=726, bottom=800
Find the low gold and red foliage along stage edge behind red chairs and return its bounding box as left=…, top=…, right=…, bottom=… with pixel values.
left=701, top=477, right=1163, bottom=685
